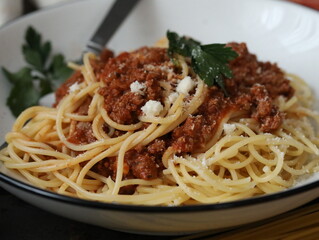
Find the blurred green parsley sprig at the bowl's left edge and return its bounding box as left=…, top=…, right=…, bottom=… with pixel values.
left=2, top=27, right=72, bottom=116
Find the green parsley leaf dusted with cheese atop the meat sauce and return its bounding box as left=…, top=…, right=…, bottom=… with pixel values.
left=167, top=31, right=238, bottom=94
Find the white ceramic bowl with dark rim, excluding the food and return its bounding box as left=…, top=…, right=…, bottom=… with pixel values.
left=0, top=0, right=319, bottom=234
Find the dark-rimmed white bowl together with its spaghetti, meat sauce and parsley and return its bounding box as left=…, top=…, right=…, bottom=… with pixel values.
left=0, top=0, right=319, bottom=234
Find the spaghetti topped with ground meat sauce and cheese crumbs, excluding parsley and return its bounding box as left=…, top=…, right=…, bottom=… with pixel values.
left=0, top=40, right=319, bottom=206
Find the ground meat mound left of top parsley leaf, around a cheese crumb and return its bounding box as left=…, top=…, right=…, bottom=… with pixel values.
left=99, top=48, right=170, bottom=124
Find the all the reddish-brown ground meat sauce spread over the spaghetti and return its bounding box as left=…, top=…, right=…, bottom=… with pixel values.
left=56, top=43, right=294, bottom=186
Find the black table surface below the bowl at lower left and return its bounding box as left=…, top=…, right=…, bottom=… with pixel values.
left=0, top=187, right=175, bottom=240
